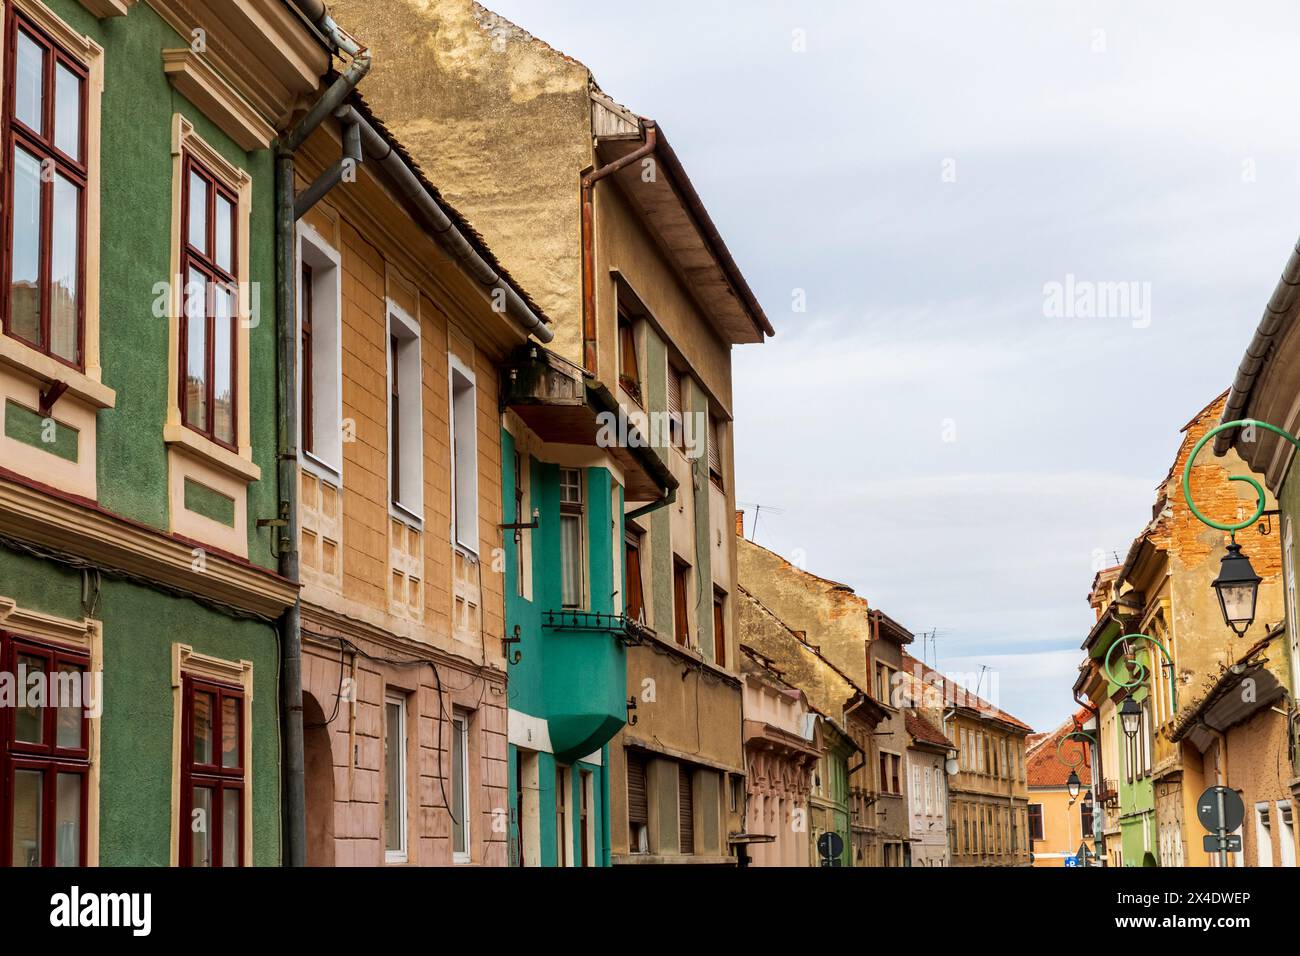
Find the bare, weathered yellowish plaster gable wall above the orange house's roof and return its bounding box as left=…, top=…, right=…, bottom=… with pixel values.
left=330, top=0, right=593, bottom=362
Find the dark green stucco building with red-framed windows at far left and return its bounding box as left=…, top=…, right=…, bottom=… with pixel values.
left=0, top=0, right=325, bottom=866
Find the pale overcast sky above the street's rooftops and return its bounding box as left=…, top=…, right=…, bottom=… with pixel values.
left=489, top=0, right=1300, bottom=730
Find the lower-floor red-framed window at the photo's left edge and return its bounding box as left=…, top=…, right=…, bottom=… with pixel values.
left=0, top=632, right=92, bottom=866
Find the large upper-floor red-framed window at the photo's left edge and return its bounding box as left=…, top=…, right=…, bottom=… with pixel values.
left=0, top=4, right=88, bottom=368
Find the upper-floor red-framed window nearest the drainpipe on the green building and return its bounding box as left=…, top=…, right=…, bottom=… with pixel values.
left=179, top=153, right=239, bottom=449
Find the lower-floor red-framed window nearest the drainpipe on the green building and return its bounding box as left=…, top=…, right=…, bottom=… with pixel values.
left=179, top=675, right=247, bottom=866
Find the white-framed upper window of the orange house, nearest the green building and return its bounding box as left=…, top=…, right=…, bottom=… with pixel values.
left=295, top=222, right=343, bottom=485
